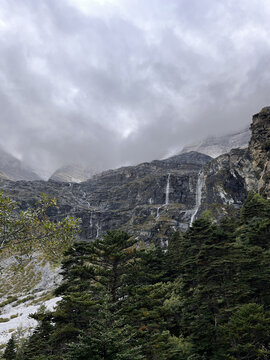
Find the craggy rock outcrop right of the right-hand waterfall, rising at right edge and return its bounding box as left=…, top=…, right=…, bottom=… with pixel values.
left=199, top=107, right=270, bottom=217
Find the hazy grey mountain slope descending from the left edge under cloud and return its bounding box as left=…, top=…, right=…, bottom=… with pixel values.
left=0, top=148, right=40, bottom=181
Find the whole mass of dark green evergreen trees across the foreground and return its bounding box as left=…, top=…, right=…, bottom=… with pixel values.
left=19, top=194, right=270, bottom=360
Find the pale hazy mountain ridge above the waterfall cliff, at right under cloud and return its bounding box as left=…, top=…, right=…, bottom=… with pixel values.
left=181, top=128, right=251, bottom=158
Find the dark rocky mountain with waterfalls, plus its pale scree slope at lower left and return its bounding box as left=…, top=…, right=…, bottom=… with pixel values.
left=0, top=107, right=270, bottom=342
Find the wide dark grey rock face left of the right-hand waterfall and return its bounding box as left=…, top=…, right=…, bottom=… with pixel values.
left=2, top=152, right=211, bottom=243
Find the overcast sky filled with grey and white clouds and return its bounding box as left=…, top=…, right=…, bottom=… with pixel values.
left=0, top=0, right=270, bottom=175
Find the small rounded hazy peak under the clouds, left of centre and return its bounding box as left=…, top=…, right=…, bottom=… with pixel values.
left=50, top=164, right=95, bottom=183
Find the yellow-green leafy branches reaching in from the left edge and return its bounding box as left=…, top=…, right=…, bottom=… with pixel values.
left=0, top=191, right=78, bottom=263
